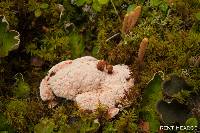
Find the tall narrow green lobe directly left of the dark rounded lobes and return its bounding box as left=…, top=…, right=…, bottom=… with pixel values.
left=140, top=72, right=163, bottom=132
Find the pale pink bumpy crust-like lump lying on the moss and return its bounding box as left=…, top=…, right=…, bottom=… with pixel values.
left=40, top=56, right=134, bottom=117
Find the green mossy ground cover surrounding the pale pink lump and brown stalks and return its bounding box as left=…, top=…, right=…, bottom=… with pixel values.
left=0, top=0, right=200, bottom=133
